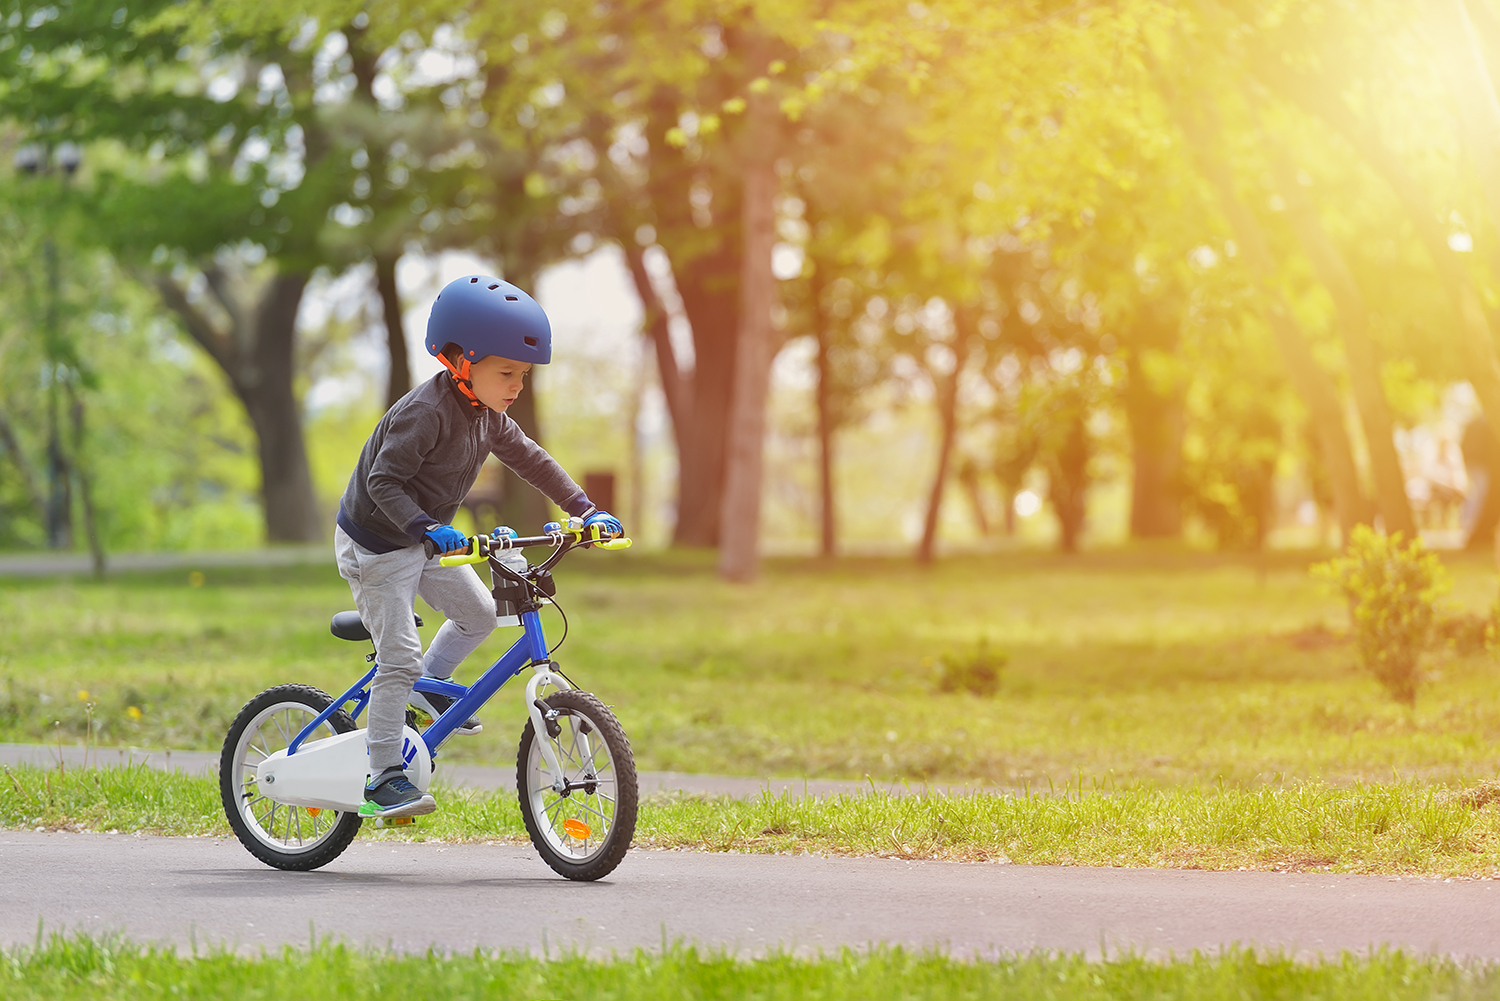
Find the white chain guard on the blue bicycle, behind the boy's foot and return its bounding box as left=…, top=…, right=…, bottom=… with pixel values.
left=255, top=726, right=432, bottom=810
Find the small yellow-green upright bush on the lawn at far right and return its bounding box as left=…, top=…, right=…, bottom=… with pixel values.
left=1313, top=525, right=1449, bottom=705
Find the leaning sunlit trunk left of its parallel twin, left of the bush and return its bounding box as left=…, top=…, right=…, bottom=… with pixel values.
left=1179, top=100, right=1371, bottom=539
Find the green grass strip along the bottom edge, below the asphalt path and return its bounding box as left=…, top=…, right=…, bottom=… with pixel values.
left=0, top=935, right=1500, bottom=1001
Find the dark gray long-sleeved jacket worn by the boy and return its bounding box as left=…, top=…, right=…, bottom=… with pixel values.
left=339, top=372, right=591, bottom=552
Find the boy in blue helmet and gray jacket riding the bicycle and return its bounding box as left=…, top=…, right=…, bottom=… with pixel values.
left=333, top=275, right=624, bottom=816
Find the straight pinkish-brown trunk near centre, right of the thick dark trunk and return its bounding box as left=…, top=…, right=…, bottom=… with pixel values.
left=717, top=95, right=779, bottom=581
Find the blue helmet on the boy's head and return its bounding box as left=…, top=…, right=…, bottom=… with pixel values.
left=426, top=275, right=552, bottom=366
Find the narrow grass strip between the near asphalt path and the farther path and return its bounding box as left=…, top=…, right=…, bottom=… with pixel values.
left=14, top=767, right=1500, bottom=876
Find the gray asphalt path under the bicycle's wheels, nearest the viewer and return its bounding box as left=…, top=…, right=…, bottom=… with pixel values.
left=0, top=831, right=1500, bottom=959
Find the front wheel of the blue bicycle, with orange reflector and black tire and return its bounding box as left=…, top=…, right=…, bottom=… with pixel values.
left=516, top=689, right=636, bottom=879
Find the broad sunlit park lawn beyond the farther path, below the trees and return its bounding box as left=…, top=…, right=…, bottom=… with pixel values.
left=0, top=552, right=1500, bottom=789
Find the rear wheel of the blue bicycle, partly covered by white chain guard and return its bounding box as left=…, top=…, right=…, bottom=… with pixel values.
left=219, top=684, right=360, bottom=870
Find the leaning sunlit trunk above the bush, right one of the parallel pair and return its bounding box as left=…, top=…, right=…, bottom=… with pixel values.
left=1269, top=138, right=1418, bottom=539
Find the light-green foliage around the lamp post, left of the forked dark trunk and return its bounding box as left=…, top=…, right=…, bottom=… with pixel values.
left=0, top=228, right=261, bottom=551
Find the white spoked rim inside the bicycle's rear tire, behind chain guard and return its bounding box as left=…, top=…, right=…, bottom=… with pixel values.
left=234, top=701, right=344, bottom=855
